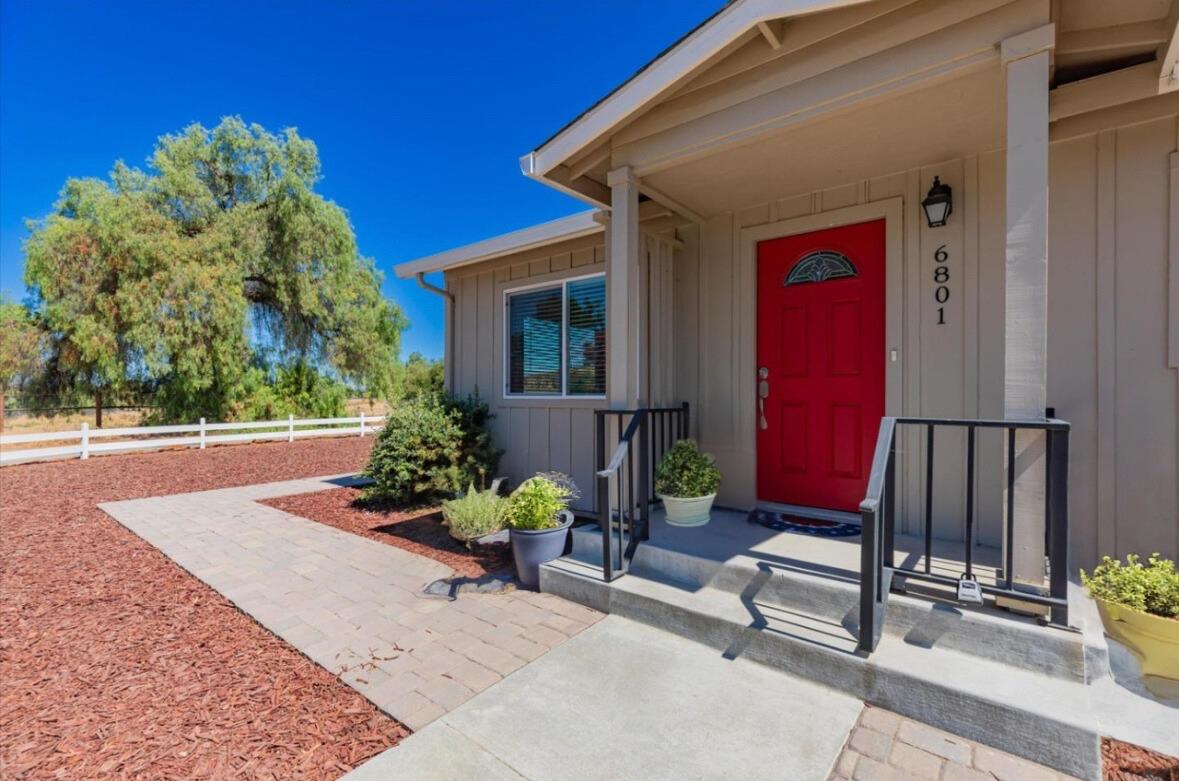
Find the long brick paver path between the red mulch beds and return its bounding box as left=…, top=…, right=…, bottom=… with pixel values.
left=101, top=478, right=601, bottom=729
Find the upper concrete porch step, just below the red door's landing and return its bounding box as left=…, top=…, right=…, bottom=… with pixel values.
left=561, top=527, right=1094, bottom=682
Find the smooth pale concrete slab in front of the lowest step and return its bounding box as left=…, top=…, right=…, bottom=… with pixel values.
left=344, top=616, right=862, bottom=781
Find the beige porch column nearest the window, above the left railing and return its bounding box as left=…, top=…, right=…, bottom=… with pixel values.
left=606, top=165, right=641, bottom=409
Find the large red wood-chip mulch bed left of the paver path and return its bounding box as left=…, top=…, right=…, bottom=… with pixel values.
left=0, top=438, right=408, bottom=779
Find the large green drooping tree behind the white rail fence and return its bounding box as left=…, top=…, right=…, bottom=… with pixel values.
left=25, top=118, right=407, bottom=419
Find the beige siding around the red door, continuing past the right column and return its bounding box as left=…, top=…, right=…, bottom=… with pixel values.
left=674, top=105, right=1179, bottom=566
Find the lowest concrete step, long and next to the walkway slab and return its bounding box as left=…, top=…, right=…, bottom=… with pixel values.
left=540, top=549, right=1100, bottom=780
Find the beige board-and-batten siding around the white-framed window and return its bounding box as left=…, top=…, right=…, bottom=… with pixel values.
left=446, top=234, right=677, bottom=512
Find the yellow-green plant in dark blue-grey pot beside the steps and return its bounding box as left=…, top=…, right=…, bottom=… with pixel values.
left=503, top=472, right=581, bottom=588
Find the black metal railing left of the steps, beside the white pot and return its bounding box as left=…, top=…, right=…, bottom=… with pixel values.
left=594, top=401, right=690, bottom=583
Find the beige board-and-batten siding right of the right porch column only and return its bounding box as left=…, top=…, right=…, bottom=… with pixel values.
left=1048, top=107, right=1179, bottom=566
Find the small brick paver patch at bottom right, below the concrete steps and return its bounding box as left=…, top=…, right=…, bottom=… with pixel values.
left=830, top=705, right=1075, bottom=781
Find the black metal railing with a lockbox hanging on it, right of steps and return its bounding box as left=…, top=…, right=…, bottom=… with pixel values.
left=859, top=418, right=1069, bottom=652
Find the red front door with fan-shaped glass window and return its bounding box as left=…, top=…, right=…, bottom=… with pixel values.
left=757, top=219, right=884, bottom=512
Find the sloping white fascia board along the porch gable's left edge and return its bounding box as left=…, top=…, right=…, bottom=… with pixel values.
left=520, top=0, right=868, bottom=178
